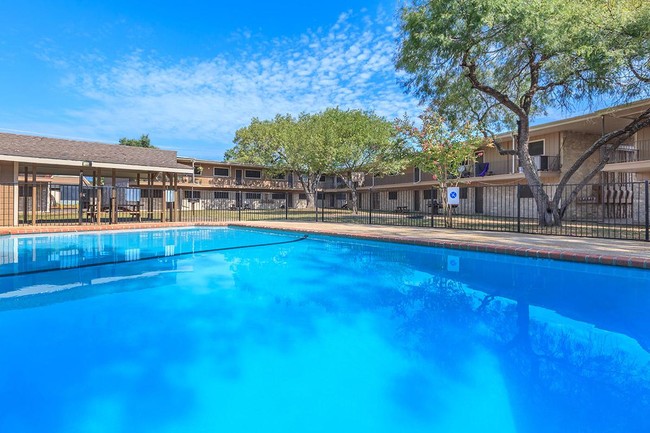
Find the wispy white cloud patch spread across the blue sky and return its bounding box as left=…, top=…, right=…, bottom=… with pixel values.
left=49, top=12, right=417, bottom=157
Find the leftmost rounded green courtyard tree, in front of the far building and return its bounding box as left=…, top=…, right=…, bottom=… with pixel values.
left=225, top=114, right=332, bottom=208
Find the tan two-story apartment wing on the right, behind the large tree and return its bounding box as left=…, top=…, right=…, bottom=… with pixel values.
left=323, top=99, right=650, bottom=218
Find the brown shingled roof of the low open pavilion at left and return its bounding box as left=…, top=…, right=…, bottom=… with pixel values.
left=0, top=133, right=191, bottom=173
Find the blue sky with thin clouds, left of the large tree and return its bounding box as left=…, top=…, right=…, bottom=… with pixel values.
left=0, top=0, right=418, bottom=159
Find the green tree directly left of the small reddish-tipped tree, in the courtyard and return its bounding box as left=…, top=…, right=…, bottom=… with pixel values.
left=317, top=108, right=408, bottom=214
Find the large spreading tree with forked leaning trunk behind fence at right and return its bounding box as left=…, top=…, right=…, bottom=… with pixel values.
left=396, top=0, right=650, bottom=225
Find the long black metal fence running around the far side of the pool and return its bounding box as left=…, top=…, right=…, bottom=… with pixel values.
left=0, top=181, right=650, bottom=241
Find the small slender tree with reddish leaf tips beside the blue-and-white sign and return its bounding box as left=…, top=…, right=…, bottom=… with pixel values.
left=395, top=108, right=489, bottom=227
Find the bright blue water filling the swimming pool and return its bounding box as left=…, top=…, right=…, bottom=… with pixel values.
left=0, top=228, right=650, bottom=433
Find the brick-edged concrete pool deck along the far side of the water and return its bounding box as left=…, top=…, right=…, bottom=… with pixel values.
left=0, top=221, right=650, bottom=269
